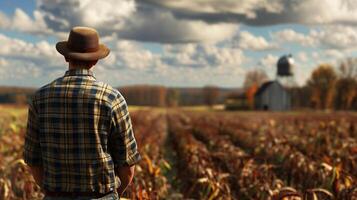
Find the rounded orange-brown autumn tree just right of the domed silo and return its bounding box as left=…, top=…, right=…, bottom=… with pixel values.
left=307, top=64, right=337, bottom=109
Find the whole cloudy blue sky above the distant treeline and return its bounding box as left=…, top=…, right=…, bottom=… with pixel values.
left=0, top=0, right=357, bottom=87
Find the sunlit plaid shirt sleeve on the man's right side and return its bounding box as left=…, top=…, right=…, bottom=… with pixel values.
left=108, top=95, right=141, bottom=167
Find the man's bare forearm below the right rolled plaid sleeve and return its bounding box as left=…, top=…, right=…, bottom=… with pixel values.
left=115, top=165, right=135, bottom=196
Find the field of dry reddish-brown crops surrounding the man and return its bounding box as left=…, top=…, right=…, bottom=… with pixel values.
left=0, top=106, right=357, bottom=200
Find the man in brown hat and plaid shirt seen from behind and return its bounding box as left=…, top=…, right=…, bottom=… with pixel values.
left=24, top=27, right=141, bottom=200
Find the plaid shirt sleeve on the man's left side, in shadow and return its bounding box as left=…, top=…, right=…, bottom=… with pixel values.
left=23, top=97, right=42, bottom=166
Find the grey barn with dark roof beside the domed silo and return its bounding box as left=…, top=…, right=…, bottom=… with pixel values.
left=254, top=81, right=291, bottom=111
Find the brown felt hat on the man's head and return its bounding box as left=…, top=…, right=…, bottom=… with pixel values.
left=56, top=26, right=110, bottom=61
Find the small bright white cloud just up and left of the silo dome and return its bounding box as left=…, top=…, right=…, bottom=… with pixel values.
left=236, top=31, right=278, bottom=51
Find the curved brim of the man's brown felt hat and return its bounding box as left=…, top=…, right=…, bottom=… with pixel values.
left=56, top=41, right=110, bottom=61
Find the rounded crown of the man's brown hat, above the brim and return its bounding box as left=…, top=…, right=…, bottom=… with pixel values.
left=67, top=27, right=99, bottom=53
